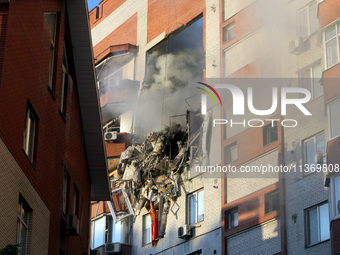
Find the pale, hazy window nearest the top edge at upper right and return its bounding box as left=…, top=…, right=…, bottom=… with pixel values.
left=298, top=1, right=319, bottom=38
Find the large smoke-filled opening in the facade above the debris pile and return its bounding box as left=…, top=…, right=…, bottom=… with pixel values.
left=135, top=17, right=205, bottom=136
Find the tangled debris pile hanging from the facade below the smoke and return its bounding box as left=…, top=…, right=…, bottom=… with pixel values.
left=110, top=112, right=206, bottom=246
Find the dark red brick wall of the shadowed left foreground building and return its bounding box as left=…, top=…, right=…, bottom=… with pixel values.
left=0, top=0, right=90, bottom=255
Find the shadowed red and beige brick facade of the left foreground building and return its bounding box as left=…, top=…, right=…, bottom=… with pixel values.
left=0, top=1, right=104, bottom=255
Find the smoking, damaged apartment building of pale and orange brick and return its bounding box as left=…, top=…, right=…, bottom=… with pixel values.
left=89, top=0, right=340, bottom=255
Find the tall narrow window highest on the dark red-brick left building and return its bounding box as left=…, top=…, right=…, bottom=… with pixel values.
left=45, top=12, right=57, bottom=89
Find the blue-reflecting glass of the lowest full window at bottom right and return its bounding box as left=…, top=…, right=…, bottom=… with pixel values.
left=306, top=203, right=330, bottom=246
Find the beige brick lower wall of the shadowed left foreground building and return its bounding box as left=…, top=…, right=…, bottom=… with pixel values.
left=0, top=139, right=49, bottom=255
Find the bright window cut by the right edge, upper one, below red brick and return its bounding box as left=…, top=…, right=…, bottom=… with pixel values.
left=324, top=22, right=340, bottom=68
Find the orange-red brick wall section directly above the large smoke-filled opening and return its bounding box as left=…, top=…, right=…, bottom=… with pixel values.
left=148, top=0, right=205, bottom=42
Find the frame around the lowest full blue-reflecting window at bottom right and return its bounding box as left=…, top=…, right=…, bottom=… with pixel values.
left=304, top=201, right=330, bottom=248
